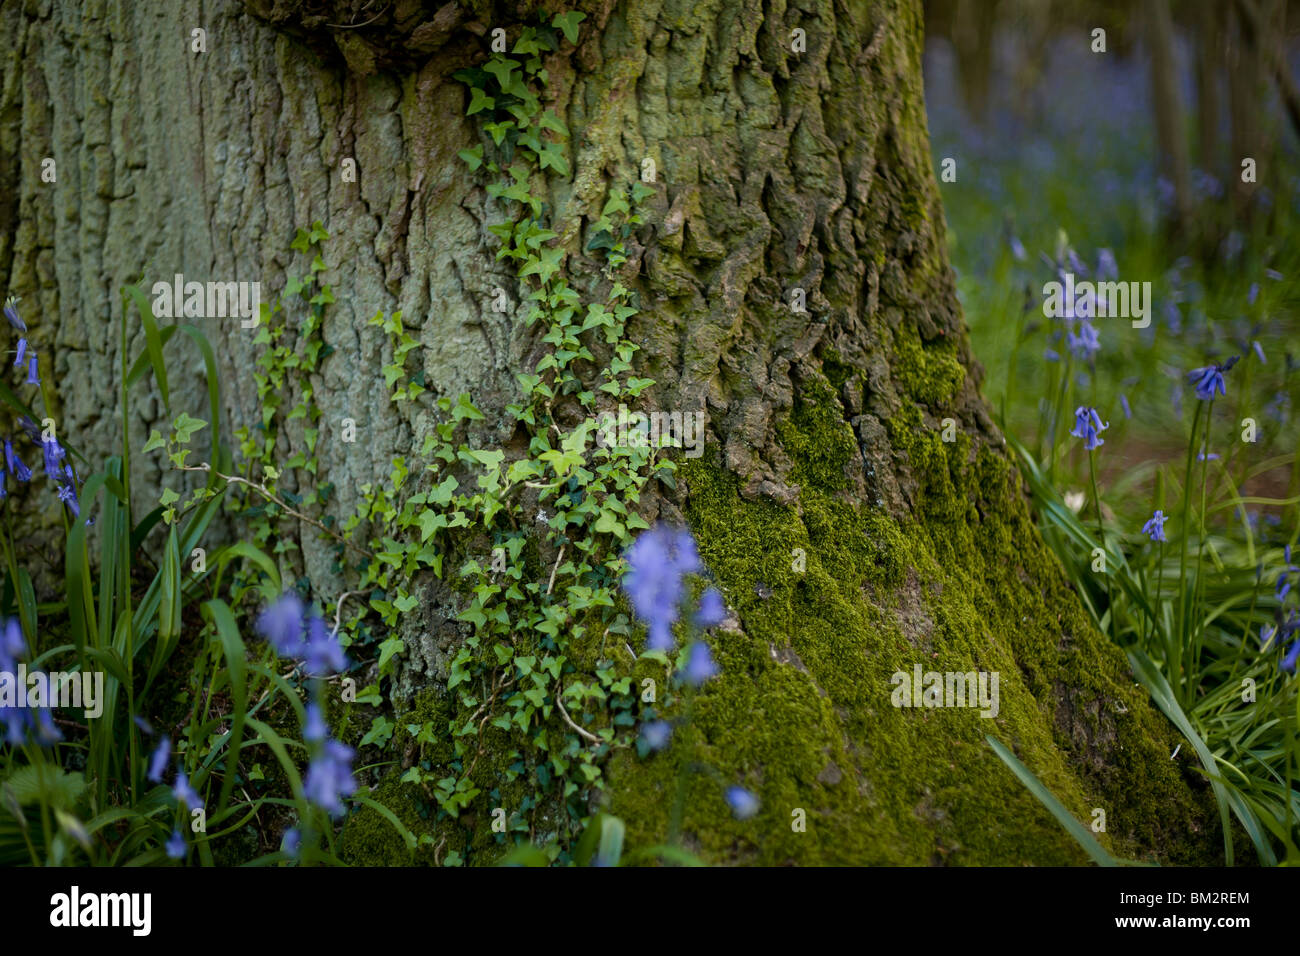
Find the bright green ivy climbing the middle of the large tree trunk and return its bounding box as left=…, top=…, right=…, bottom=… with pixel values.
left=345, top=22, right=691, bottom=862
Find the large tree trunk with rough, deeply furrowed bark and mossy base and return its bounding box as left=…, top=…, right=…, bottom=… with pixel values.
left=0, top=0, right=1216, bottom=864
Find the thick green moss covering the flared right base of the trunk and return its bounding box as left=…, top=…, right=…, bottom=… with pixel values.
left=608, top=421, right=1213, bottom=865
